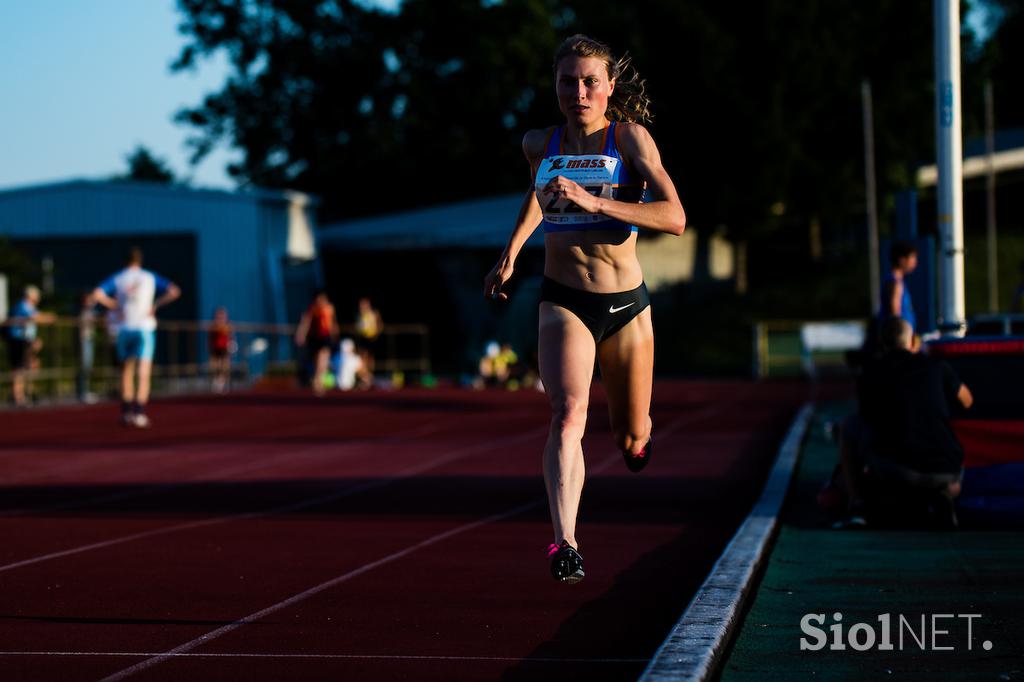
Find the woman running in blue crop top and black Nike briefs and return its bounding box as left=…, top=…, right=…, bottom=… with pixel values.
left=483, top=35, right=686, bottom=584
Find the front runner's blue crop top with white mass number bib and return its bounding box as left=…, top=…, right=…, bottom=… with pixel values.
left=535, top=121, right=644, bottom=232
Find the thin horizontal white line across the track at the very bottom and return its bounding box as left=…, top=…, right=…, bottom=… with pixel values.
left=0, top=651, right=647, bottom=665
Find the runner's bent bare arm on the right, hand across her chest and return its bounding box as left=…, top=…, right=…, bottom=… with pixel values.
left=552, top=123, right=686, bottom=235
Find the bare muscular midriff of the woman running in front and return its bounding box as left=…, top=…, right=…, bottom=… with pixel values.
left=544, top=229, right=643, bottom=294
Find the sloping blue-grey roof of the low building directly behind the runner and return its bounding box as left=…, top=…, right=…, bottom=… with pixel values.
left=316, top=193, right=544, bottom=251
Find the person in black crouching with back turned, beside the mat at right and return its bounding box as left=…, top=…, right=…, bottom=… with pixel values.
left=837, top=317, right=974, bottom=527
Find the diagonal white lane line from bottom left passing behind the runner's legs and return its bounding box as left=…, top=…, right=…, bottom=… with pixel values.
left=100, top=407, right=722, bottom=682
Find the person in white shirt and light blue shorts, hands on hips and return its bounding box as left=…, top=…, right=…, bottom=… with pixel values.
left=92, top=248, right=181, bottom=428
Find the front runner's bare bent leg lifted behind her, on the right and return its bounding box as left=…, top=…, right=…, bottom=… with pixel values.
left=597, top=306, right=654, bottom=455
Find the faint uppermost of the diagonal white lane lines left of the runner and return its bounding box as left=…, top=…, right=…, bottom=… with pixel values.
left=0, top=425, right=441, bottom=518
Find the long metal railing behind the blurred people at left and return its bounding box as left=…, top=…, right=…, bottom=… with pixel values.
left=0, top=317, right=431, bottom=402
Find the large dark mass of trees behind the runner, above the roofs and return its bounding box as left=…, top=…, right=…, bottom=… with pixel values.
left=167, top=0, right=1007, bottom=233
